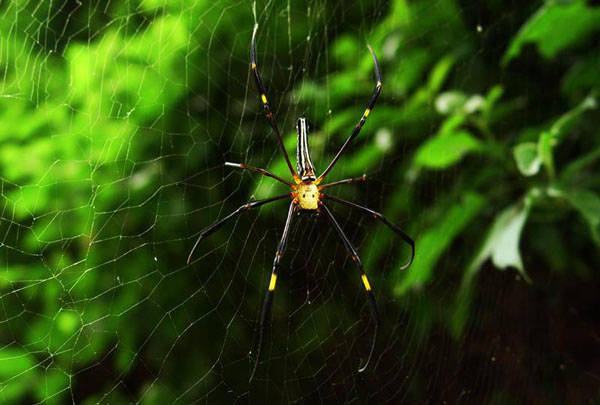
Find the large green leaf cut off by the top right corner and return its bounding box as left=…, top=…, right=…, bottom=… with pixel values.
left=502, top=0, right=600, bottom=64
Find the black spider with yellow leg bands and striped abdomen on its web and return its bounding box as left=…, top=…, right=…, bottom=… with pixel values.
left=187, top=24, right=415, bottom=380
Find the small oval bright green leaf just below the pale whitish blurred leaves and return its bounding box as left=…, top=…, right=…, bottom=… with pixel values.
left=415, top=130, right=481, bottom=169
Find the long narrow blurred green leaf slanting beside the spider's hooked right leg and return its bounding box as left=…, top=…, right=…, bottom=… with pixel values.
left=394, top=192, right=486, bottom=295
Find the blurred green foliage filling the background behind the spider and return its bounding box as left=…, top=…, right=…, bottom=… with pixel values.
left=0, top=0, right=600, bottom=403
